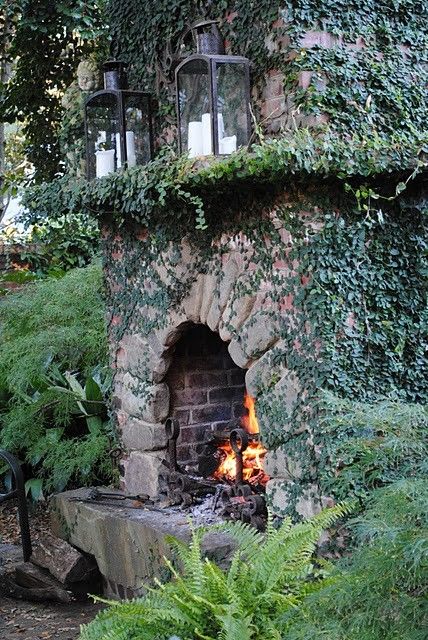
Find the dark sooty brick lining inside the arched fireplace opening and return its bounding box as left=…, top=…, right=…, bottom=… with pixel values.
left=165, top=325, right=245, bottom=464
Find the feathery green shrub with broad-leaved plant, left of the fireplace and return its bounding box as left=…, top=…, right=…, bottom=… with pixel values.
left=0, top=265, right=112, bottom=491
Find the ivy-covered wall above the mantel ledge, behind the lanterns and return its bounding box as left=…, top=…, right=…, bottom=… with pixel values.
left=109, top=0, right=428, bottom=168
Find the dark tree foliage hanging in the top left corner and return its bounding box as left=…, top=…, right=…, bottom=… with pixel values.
left=0, top=0, right=105, bottom=181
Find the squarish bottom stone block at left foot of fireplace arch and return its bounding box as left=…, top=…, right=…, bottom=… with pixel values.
left=122, top=451, right=166, bottom=498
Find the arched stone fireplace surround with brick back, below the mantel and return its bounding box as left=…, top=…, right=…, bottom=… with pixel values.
left=103, top=191, right=321, bottom=515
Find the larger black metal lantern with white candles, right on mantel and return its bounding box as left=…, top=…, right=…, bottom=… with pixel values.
left=175, top=20, right=251, bottom=157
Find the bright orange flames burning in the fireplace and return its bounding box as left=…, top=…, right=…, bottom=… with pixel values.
left=214, top=394, right=269, bottom=485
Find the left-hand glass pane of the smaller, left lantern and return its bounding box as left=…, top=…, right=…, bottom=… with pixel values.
left=86, top=93, right=120, bottom=179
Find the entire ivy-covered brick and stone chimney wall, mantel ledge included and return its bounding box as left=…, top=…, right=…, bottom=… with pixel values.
left=20, top=0, right=428, bottom=514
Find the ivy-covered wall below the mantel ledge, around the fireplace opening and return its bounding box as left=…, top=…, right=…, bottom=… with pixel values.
left=103, top=182, right=428, bottom=515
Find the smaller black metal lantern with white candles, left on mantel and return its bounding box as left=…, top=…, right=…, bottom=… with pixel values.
left=85, top=60, right=153, bottom=180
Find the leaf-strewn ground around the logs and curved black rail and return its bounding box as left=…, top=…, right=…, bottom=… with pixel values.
left=0, top=502, right=100, bottom=640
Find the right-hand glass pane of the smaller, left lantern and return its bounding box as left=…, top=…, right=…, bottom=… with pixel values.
left=122, top=93, right=151, bottom=167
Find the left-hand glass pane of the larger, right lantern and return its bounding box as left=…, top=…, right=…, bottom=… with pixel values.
left=177, top=60, right=212, bottom=158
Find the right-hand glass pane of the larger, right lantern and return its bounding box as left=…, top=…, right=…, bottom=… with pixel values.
left=216, top=60, right=249, bottom=155
